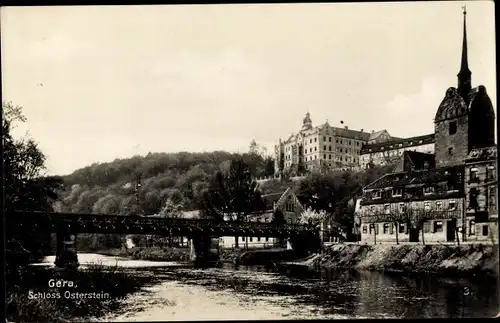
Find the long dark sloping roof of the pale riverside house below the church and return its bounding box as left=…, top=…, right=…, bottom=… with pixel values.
left=364, top=165, right=464, bottom=190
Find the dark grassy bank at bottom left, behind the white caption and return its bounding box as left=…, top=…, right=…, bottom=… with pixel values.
left=6, top=265, right=154, bottom=322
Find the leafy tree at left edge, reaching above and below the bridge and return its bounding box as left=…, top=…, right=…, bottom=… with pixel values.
left=2, top=102, right=63, bottom=272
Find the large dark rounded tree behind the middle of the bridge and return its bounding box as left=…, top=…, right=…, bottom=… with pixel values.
left=201, top=159, right=264, bottom=247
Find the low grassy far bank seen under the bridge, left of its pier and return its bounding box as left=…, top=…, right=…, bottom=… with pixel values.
left=96, top=247, right=189, bottom=261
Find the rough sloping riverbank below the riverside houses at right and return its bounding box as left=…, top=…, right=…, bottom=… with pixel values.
left=284, top=244, right=498, bottom=276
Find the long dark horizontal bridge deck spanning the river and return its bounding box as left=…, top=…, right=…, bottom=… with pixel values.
left=6, top=212, right=328, bottom=237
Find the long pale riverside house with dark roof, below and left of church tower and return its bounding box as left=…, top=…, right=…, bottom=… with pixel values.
left=359, top=165, right=464, bottom=243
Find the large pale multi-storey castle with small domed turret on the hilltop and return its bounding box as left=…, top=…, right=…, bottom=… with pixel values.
left=275, top=113, right=391, bottom=175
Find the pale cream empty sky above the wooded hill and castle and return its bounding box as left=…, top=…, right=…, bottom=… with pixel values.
left=0, top=1, right=496, bottom=175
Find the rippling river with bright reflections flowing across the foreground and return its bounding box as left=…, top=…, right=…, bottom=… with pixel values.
left=35, top=254, right=498, bottom=321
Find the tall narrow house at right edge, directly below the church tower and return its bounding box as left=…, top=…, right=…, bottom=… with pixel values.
left=465, top=146, right=498, bottom=242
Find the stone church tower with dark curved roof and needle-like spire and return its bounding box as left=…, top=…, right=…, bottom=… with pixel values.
left=434, top=7, right=495, bottom=167
